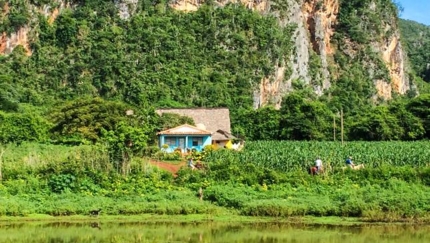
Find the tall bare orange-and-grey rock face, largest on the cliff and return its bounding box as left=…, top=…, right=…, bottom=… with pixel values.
left=254, top=0, right=339, bottom=108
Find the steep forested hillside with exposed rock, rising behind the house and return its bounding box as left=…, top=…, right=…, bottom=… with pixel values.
left=0, top=0, right=429, bottom=146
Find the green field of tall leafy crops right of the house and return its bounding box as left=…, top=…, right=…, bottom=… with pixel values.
left=207, top=141, right=430, bottom=171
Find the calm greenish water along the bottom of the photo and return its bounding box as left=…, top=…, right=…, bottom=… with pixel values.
left=0, top=222, right=430, bottom=243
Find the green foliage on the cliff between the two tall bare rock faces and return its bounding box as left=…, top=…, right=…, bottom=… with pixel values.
left=323, top=0, right=398, bottom=114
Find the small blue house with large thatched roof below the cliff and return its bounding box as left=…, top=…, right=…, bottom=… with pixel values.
left=156, top=108, right=235, bottom=151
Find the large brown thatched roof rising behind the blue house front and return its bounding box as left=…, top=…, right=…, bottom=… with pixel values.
left=156, top=108, right=231, bottom=140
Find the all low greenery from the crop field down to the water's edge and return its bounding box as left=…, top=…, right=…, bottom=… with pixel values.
left=0, top=142, right=430, bottom=221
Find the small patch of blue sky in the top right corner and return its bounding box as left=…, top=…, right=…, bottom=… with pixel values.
left=394, top=0, right=430, bottom=26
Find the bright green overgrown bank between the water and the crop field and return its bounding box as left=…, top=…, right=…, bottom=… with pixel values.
left=0, top=143, right=430, bottom=223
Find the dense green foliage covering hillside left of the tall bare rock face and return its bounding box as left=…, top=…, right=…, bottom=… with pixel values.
left=1, top=1, right=293, bottom=111
